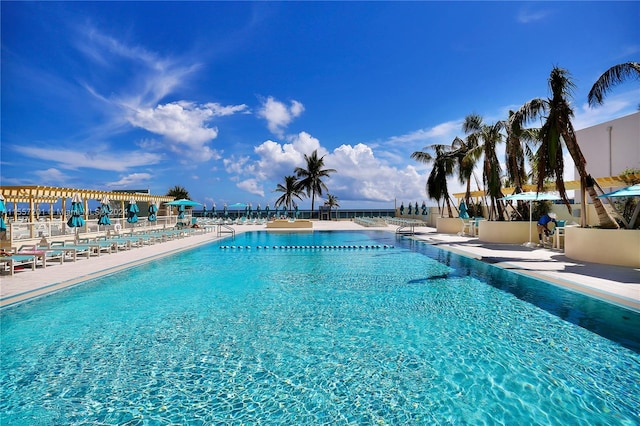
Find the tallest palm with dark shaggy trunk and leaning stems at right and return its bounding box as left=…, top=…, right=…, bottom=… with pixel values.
left=514, top=67, right=619, bottom=228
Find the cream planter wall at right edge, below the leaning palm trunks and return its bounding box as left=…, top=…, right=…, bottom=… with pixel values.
left=564, top=227, right=640, bottom=268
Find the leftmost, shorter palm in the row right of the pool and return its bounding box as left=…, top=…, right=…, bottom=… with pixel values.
left=411, top=144, right=456, bottom=217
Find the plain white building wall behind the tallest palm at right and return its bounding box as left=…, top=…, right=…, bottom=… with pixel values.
left=575, top=112, right=640, bottom=203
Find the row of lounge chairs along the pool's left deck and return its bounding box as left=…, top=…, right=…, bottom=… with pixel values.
left=0, top=228, right=206, bottom=275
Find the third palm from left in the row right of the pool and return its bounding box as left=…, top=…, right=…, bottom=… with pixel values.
left=462, top=114, right=504, bottom=220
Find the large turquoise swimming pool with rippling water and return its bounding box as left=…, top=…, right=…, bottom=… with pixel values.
left=0, top=232, right=640, bottom=425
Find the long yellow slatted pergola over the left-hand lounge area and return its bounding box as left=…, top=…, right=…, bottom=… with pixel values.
left=0, top=185, right=174, bottom=222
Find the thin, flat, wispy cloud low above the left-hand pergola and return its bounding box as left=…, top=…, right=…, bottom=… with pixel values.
left=13, top=145, right=162, bottom=172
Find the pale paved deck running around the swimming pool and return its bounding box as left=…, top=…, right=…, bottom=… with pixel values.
left=0, top=221, right=640, bottom=312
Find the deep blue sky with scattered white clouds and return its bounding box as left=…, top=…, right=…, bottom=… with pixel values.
left=0, top=1, right=640, bottom=208
